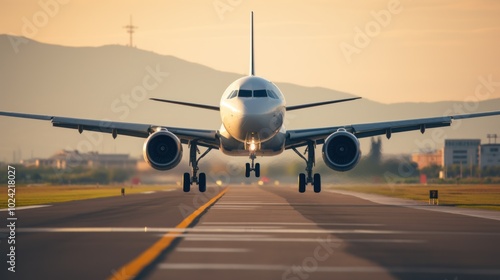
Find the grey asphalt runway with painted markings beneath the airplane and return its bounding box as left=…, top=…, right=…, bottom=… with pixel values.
left=0, top=186, right=500, bottom=280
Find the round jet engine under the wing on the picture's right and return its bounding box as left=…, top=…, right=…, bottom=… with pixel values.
left=323, top=128, right=361, bottom=171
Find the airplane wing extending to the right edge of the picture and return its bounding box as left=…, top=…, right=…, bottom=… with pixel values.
left=285, top=111, right=500, bottom=149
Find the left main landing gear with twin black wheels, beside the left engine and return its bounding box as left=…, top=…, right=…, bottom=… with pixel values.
left=182, top=141, right=212, bottom=192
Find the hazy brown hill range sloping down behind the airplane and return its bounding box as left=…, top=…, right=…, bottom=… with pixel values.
left=0, top=35, right=500, bottom=164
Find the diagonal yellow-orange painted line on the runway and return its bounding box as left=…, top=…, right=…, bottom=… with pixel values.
left=109, top=188, right=227, bottom=280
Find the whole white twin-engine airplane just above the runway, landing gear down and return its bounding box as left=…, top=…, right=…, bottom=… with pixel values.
left=0, top=12, right=500, bottom=193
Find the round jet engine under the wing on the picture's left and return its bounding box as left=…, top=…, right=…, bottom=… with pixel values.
left=142, top=129, right=182, bottom=170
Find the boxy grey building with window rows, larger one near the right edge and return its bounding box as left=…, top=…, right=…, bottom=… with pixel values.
left=443, top=139, right=481, bottom=167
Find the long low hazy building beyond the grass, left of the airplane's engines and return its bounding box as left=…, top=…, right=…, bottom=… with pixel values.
left=22, top=150, right=137, bottom=169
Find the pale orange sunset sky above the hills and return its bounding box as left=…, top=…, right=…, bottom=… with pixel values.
left=0, top=0, right=500, bottom=103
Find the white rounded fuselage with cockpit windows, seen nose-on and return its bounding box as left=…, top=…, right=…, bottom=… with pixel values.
left=220, top=76, right=286, bottom=156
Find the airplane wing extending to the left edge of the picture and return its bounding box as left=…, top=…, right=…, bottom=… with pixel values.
left=0, top=111, right=219, bottom=149
